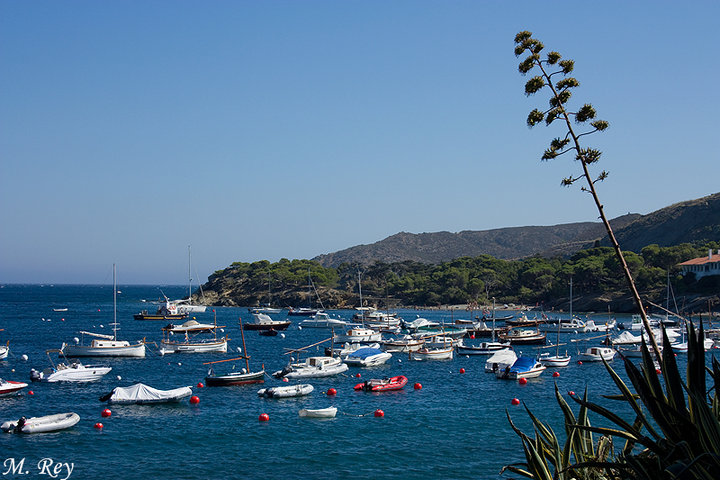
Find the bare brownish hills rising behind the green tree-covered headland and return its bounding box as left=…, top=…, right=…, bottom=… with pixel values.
left=313, top=193, right=720, bottom=267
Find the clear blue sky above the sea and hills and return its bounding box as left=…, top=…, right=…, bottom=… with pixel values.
left=0, top=0, right=720, bottom=284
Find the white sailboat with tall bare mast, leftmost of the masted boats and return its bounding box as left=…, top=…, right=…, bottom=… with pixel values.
left=60, top=264, right=145, bottom=358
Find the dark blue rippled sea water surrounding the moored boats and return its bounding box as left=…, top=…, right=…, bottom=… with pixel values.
left=0, top=285, right=684, bottom=480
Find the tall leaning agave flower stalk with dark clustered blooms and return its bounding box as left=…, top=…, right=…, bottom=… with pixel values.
left=515, top=31, right=659, bottom=355
